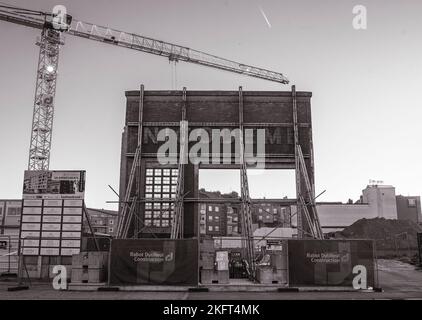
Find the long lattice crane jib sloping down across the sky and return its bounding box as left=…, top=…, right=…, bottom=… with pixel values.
left=0, top=6, right=289, bottom=84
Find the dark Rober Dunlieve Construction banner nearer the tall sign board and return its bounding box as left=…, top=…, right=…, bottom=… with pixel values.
left=109, top=239, right=198, bottom=286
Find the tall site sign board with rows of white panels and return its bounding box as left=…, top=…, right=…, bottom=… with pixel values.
left=20, top=171, right=85, bottom=255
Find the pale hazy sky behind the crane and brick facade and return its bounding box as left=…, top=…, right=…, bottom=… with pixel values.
left=0, top=0, right=422, bottom=209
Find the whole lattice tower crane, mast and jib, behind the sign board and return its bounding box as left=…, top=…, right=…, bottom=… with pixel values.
left=0, top=3, right=289, bottom=170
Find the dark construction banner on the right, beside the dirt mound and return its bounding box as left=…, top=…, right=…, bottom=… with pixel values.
left=288, top=240, right=376, bottom=287
